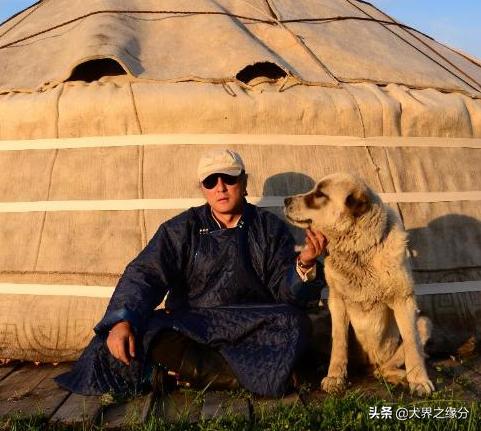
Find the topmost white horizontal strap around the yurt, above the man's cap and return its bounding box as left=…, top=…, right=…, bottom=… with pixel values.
left=0, top=133, right=481, bottom=152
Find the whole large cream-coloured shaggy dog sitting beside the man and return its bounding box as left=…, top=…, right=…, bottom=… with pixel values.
left=285, top=174, right=434, bottom=395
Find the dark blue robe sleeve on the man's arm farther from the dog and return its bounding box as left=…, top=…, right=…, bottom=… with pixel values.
left=94, top=224, right=186, bottom=335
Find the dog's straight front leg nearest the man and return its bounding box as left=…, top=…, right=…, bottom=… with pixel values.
left=321, top=295, right=349, bottom=393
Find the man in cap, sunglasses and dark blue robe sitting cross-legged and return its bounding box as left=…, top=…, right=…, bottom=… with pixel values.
left=57, top=150, right=326, bottom=396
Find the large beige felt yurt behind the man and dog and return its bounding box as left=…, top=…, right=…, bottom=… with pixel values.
left=0, top=0, right=481, bottom=362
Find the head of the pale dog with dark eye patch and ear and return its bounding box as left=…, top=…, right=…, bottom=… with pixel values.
left=284, top=173, right=379, bottom=238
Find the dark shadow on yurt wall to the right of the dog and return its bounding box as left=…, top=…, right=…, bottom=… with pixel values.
left=408, top=214, right=481, bottom=356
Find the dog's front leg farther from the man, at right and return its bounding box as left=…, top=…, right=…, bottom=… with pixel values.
left=393, top=296, right=434, bottom=395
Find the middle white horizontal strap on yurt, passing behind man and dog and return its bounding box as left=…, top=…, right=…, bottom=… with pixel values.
left=0, top=191, right=481, bottom=213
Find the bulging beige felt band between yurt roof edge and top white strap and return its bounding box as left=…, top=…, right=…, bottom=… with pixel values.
left=0, top=81, right=481, bottom=139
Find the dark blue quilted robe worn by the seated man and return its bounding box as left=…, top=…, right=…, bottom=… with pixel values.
left=57, top=201, right=323, bottom=396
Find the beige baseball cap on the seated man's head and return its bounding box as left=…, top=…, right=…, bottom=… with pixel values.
left=197, top=149, right=245, bottom=181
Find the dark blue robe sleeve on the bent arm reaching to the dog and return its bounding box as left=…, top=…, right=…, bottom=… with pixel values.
left=267, top=220, right=325, bottom=308
